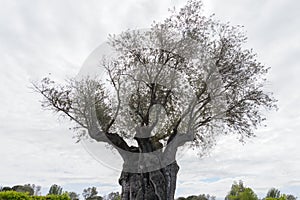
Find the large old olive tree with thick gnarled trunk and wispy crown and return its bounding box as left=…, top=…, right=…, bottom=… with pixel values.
left=34, top=0, right=275, bottom=200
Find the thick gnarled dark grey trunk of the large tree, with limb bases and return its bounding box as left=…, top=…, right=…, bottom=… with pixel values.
left=86, top=114, right=194, bottom=200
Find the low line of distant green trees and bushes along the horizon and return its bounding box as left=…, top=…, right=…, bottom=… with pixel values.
left=0, top=181, right=297, bottom=200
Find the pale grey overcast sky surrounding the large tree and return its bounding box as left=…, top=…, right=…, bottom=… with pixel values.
left=0, top=0, right=300, bottom=199
